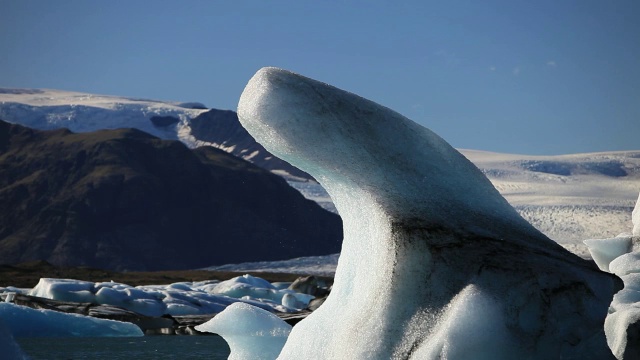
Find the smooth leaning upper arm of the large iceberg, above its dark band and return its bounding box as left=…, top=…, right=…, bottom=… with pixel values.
left=238, top=68, right=537, bottom=242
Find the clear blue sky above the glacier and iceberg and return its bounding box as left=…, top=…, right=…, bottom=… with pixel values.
left=0, top=0, right=640, bottom=154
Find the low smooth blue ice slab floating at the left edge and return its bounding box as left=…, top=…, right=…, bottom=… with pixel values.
left=0, top=303, right=143, bottom=337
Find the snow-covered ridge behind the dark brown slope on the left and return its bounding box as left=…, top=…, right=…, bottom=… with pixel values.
left=0, top=88, right=310, bottom=180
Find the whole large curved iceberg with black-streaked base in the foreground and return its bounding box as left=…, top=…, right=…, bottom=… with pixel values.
left=238, top=68, right=621, bottom=360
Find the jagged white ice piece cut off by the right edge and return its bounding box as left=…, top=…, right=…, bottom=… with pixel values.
left=584, top=190, right=640, bottom=359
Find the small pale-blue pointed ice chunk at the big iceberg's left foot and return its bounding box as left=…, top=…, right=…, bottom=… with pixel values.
left=196, top=302, right=291, bottom=360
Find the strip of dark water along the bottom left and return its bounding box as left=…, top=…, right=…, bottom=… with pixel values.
left=16, top=335, right=229, bottom=360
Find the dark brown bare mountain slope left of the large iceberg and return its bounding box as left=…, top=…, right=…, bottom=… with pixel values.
left=0, top=121, right=342, bottom=270
